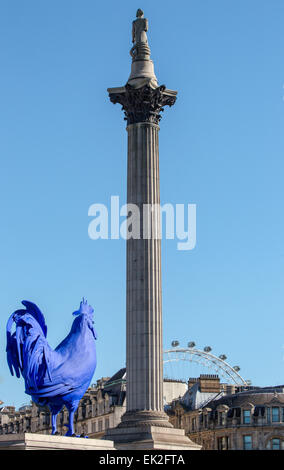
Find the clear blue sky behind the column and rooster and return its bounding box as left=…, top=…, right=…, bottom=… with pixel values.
left=0, top=0, right=284, bottom=406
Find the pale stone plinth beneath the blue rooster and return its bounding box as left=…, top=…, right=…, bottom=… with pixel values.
left=0, top=433, right=115, bottom=450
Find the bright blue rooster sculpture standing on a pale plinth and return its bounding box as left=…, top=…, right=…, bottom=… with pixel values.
left=6, top=299, right=97, bottom=436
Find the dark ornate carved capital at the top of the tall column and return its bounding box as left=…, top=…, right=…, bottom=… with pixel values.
left=109, top=84, right=177, bottom=124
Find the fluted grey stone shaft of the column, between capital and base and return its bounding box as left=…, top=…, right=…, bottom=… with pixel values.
left=126, top=122, right=163, bottom=412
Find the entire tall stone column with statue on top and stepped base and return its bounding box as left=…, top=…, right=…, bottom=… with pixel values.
left=105, top=9, right=200, bottom=450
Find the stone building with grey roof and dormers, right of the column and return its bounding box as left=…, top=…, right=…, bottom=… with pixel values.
left=168, top=376, right=284, bottom=450
